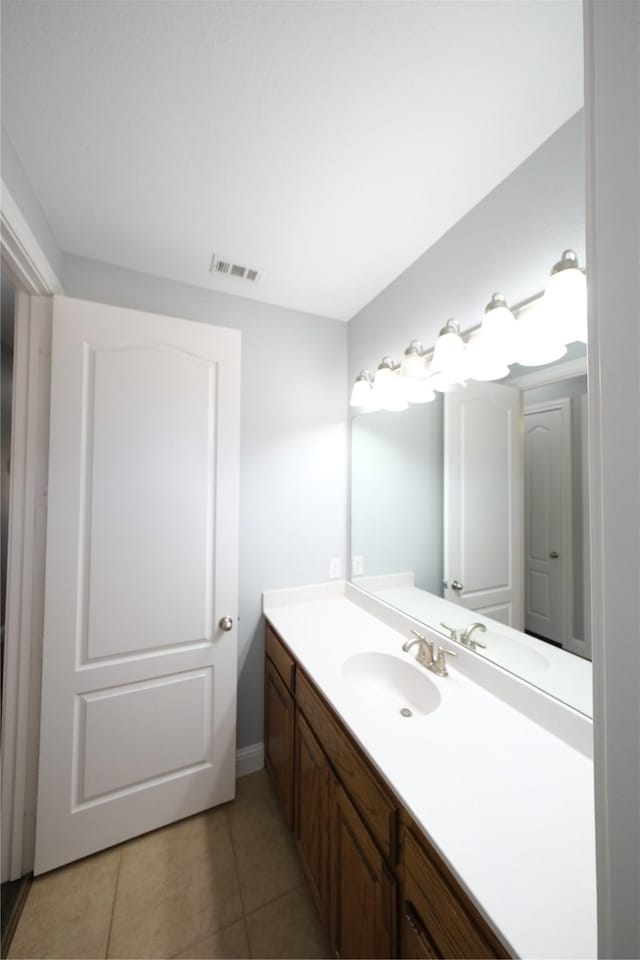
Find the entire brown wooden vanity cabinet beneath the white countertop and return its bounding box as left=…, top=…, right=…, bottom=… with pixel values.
left=265, top=626, right=509, bottom=960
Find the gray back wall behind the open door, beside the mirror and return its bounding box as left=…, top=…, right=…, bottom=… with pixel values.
left=62, top=255, right=347, bottom=747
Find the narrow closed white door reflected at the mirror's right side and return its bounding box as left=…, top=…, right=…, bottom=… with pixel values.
left=524, top=399, right=572, bottom=646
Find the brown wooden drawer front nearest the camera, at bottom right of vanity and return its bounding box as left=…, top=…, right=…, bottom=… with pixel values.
left=403, top=828, right=509, bottom=960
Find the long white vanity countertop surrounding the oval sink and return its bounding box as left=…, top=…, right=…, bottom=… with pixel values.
left=264, top=586, right=597, bottom=960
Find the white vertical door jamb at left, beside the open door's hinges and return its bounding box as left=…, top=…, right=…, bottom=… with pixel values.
left=2, top=293, right=52, bottom=881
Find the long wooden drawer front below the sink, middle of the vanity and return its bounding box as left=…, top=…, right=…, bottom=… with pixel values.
left=296, top=670, right=398, bottom=864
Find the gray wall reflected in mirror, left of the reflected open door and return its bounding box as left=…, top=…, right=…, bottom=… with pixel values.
left=351, top=394, right=443, bottom=596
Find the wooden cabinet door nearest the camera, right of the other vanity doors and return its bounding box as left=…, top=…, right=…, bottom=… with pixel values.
left=331, top=783, right=396, bottom=960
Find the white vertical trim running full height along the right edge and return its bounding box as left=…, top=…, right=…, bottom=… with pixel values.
left=584, top=0, right=640, bottom=957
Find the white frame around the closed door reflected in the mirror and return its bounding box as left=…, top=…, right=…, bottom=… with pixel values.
left=522, top=397, right=575, bottom=653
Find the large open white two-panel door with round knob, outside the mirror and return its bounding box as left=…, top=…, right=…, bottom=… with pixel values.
left=34, top=297, right=240, bottom=874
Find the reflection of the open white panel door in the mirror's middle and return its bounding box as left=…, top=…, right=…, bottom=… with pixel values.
left=444, top=382, right=523, bottom=629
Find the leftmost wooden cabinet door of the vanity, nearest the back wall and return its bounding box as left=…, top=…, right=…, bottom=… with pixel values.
left=264, top=659, right=294, bottom=826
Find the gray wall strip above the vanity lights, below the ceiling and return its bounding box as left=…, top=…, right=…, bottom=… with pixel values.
left=349, top=112, right=585, bottom=380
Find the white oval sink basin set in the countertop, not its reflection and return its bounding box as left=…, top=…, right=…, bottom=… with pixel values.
left=342, top=653, right=440, bottom=717
